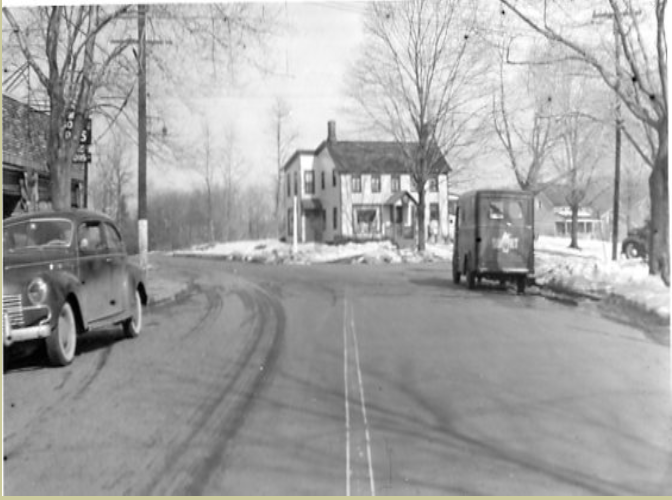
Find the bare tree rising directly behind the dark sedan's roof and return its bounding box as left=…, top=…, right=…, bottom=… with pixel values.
left=2, top=5, right=136, bottom=209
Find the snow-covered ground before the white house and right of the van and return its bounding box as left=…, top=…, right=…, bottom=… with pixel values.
left=174, top=236, right=670, bottom=318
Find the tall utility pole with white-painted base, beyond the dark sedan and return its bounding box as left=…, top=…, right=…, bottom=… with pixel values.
left=138, top=4, right=148, bottom=271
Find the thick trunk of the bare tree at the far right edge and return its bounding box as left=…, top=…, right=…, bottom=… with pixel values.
left=649, top=121, right=670, bottom=286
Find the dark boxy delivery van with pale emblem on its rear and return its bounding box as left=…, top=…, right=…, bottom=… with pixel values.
left=453, top=189, right=534, bottom=293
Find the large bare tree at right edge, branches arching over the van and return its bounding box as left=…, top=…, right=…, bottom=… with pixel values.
left=501, top=0, right=670, bottom=286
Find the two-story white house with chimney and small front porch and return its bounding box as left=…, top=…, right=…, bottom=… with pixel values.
left=281, top=121, right=450, bottom=246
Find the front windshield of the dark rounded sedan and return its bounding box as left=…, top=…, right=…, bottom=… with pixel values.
left=2, top=219, right=73, bottom=252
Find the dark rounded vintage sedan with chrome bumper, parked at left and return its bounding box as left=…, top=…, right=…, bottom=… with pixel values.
left=2, top=210, right=147, bottom=366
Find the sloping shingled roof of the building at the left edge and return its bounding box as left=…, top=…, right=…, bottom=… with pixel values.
left=2, top=95, right=49, bottom=172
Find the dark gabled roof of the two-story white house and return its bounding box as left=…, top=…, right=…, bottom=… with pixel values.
left=315, top=141, right=450, bottom=174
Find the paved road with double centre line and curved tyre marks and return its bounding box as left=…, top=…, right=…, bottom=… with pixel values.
left=4, top=259, right=672, bottom=495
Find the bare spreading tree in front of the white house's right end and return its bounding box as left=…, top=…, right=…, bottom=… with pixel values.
left=352, top=0, right=485, bottom=250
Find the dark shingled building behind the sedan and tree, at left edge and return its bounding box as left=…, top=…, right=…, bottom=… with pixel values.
left=2, top=95, right=86, bottom=218
